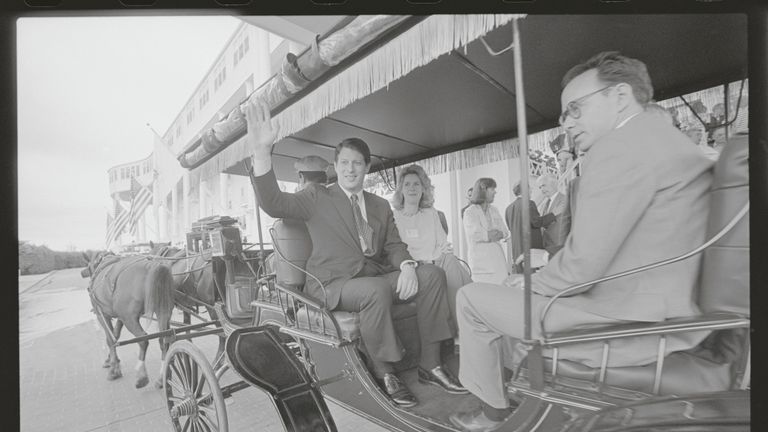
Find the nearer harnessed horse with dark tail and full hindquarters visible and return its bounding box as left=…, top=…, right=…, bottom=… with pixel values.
left=81, top=252, right=174, bottom=388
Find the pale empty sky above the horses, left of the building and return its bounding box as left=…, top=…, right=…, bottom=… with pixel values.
left=16, top=16, right=240, bottom=250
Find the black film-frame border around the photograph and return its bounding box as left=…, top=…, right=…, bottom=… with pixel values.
left=0, top=0, right=768, bottom=430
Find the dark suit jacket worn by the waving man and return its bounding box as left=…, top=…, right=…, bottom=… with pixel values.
left=253, top=170, right=412, bottom=309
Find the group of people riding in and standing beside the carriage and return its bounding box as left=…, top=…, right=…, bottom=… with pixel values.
left=246, top=52, right=744, bottom=431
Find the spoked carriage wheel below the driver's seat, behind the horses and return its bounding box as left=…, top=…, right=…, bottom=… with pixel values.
left=163, top=341, right=229, bottom=432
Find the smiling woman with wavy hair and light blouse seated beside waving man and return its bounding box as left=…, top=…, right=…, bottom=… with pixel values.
left=391, top=165, right=472, bottom=332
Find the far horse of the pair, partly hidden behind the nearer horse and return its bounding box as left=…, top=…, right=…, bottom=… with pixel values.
left=149, top=245, right=224, bottom=357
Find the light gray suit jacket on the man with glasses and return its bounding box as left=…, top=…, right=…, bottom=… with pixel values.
left=532, top=113, right=712, bottom=330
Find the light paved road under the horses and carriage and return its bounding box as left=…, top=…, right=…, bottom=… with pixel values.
left=19, top=269, right=385, bottom=432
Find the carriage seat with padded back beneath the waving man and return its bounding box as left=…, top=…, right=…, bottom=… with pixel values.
left=270, top=219, right=420, bottom=370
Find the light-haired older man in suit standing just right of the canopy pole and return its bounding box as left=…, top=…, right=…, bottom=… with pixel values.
left=536, top=174, right=570, bottom=257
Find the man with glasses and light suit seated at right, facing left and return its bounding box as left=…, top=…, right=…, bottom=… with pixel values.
left=451, top=52, right=712, bottom=431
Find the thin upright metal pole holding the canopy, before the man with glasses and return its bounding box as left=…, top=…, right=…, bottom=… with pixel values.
left=512, top=18, right=531, bottom=340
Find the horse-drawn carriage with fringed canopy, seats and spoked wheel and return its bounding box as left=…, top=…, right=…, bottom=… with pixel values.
left=87, top=11, right=751, bottom=431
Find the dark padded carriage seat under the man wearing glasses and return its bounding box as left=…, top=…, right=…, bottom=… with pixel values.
left=507, top=134, right=750, bottom=394
